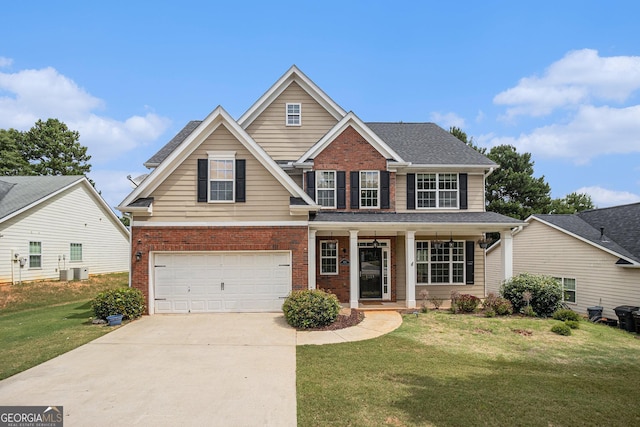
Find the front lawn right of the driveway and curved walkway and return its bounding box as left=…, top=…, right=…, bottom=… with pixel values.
left=297, top=312, right=640, bottom=426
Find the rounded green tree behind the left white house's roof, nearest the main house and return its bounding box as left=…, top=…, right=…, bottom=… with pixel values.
left=24, top=119, right=91, bottom=175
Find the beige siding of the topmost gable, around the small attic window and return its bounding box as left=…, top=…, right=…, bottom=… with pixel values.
left=247, top=82, right=338, bottom=160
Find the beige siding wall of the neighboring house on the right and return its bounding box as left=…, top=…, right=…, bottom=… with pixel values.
left=489, top=221, right=640, bottom=319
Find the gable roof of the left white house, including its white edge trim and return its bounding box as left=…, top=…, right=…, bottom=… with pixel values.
left=0, top=175, right=129, bottom=235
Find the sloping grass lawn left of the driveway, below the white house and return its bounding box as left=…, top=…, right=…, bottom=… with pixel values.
left=0, top=273, right=128, bottom=379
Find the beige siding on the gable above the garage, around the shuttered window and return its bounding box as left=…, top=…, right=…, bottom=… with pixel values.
left=142, top=126, right=304, bottom=222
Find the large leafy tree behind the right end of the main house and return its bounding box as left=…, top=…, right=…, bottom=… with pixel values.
left=486, top=145, right=551, bottom=220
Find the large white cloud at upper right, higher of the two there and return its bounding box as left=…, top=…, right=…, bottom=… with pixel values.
left=493, top=49, right=640, bottom=118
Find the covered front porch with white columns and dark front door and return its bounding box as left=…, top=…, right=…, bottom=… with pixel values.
left=308, top=212, right=522, bottom=310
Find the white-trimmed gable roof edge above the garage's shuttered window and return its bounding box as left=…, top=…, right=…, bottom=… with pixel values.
left=116, top=106, right=316, bottom=212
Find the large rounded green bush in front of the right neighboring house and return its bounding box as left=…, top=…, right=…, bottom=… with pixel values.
left=500, top=273, right=562, bottom=317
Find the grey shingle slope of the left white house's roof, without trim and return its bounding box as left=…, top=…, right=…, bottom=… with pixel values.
left=0, top=175, right=84, bottom=219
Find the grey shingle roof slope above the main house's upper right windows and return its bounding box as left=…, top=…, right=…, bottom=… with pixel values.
left=366, top=122, right=497, bottom=167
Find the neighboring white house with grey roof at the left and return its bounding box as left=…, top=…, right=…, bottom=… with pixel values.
left=0, top=176, right=129, bottom=283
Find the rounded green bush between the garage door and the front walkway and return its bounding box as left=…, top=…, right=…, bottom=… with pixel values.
left=282, top=289, right=340, bottom=329
